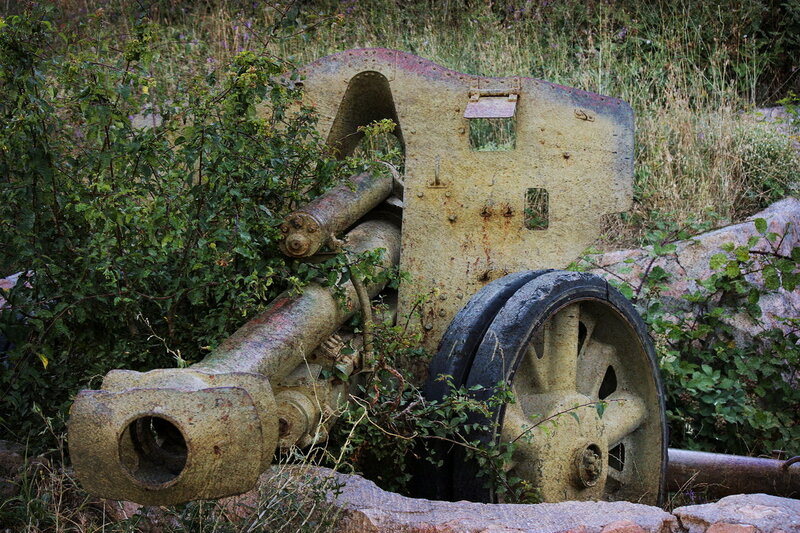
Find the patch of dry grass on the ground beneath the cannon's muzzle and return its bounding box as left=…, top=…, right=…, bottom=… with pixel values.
left=0, top=438, right=342, bottom=533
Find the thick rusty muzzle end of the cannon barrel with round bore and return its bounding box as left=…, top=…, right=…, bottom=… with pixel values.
left=68, top=373, right=278, bottom=505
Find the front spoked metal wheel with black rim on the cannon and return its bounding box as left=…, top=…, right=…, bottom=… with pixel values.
left=428, top=272, right=666, bottom=504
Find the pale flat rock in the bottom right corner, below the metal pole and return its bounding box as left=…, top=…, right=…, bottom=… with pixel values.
left=673, top=494, right=800, bottom=533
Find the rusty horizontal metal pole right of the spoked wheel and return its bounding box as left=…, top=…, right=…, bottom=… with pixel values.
left=667, top=448, right=800, bottom=498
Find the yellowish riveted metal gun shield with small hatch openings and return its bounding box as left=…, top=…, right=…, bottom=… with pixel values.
left=302, top=48, right=633, bottom=351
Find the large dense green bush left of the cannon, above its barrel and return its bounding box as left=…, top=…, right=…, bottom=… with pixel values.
left=0, top=12, right=354, bottom=439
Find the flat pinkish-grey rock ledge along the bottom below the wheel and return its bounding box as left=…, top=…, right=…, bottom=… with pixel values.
left=103, top=466, right=800, bottom=533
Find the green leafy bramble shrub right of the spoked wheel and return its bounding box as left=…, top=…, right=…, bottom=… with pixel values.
left=580, top=219, right=800, bottom=455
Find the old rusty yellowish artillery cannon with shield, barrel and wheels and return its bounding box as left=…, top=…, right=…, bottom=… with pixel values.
left=69, top=49, right=800, bottom=504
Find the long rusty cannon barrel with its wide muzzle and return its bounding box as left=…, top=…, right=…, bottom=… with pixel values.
left=68, top=171, right=400, bottom=505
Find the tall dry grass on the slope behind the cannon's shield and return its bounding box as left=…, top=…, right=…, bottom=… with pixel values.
left=47, top=0, right=796, bottom=246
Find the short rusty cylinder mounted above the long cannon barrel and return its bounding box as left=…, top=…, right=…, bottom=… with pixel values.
left=281, top=172, right=392, bottom=257
